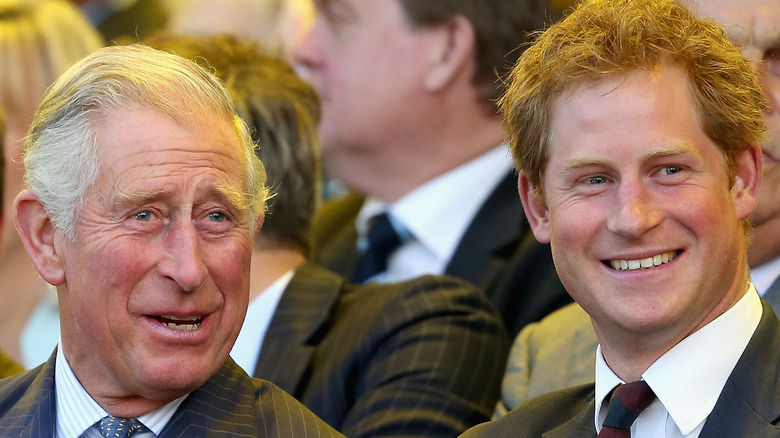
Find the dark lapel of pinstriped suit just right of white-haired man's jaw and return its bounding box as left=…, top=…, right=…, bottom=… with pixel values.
left=254, top=263, right=344, bottom=397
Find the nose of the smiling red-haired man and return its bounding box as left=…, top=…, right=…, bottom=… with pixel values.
left=607, top=183, right=663, bottom=239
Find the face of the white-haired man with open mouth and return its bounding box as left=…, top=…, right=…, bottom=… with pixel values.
left=55, top=105, right=254, bottom=400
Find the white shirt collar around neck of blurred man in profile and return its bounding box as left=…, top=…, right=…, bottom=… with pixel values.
left=355, top=143, right=520, bottom=263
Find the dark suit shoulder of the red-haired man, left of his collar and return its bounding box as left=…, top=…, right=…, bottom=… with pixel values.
left=462, top=383, right=594, bottom=438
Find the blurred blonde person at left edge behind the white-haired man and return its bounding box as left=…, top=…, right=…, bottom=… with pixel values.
left=0, top=0, right=103, bottom=367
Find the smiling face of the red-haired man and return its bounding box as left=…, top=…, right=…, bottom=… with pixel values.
left=520, top=66, right=760, bottom=342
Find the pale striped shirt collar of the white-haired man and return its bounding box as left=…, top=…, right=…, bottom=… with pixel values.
left=54, top=340, right=187, bottom=438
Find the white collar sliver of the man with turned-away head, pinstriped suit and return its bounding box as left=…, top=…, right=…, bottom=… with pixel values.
left=230, top=269, right=295, bottom=376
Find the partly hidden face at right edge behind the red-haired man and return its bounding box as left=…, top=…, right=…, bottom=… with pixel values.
left=685, top=0, right=780, bottom=231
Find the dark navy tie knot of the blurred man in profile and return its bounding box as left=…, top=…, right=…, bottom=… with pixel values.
left=352, top=213, right=403, bottom=283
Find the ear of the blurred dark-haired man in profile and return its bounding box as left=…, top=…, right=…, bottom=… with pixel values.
left=425, top=15, right=476, bottom=92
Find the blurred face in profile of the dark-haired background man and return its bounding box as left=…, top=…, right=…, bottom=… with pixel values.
left=294, top=0, right=435, bottom=170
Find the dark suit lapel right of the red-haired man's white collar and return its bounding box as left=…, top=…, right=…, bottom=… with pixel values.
left=700, top=302, right=780, bottom=438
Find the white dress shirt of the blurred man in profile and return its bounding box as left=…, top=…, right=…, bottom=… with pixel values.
left=355, top=144, right=520, bottom=282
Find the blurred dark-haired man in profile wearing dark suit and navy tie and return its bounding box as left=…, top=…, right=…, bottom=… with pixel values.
left=294, top=0, right=571, bottom=334
